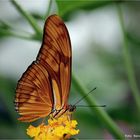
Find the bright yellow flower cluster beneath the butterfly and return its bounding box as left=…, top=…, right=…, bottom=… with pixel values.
left=27, top=114, right=79, bottom=140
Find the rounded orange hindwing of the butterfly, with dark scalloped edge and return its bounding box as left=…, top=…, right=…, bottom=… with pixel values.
left=15, top=63, right=53, bottom=122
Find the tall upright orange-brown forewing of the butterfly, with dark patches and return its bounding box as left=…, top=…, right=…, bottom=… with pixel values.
left=37, top=15, right=71, bottom=110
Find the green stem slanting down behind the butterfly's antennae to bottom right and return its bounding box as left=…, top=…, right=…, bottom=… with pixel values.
left=72, top=74, right=124, bottom=139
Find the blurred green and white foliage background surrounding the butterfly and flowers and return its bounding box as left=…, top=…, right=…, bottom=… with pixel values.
left=0, top=0, right=140, bottom=140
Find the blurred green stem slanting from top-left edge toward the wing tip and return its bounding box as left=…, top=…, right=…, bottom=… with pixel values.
left=11, top=0, right=42, bottom=36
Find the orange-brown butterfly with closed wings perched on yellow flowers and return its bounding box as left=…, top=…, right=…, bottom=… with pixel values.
left=15, top=15, right=75, bottom=122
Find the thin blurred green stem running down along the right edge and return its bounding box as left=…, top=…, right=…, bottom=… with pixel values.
left=117, top=4, right=140, bottom=112
